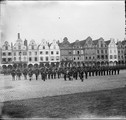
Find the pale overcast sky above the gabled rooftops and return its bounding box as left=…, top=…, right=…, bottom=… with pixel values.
left=2, top=1, right=125, bottom=43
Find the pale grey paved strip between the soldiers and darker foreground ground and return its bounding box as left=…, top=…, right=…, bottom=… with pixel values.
left=0, top=70, right=126, bottom=102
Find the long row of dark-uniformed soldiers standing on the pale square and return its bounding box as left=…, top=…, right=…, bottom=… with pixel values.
left=11, top=66, right=120, bottom=82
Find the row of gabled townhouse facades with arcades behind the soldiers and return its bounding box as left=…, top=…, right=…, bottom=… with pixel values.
left=1, top=33, right=126, bottom=65
